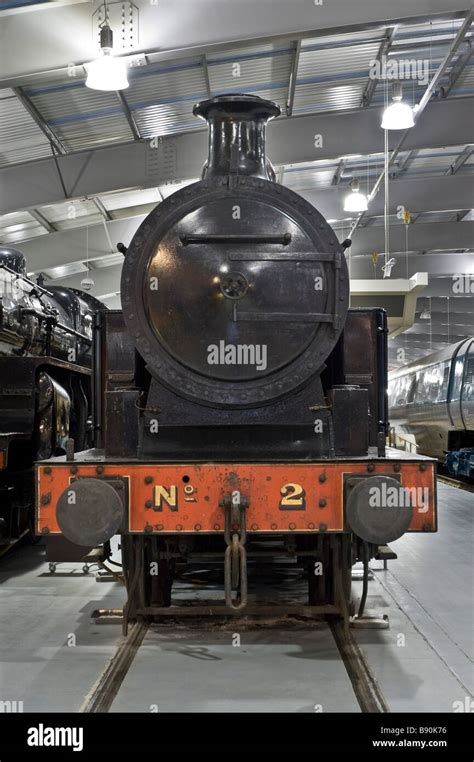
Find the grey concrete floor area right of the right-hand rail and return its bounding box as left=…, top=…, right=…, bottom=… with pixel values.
left=357, top=482, right=474, bottom=712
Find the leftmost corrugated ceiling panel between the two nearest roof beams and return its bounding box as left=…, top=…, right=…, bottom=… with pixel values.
left=0, top=90, right=51, bottom=166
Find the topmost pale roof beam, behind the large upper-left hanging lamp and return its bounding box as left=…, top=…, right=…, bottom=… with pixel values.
left=0, top=0, right=465, bottom=88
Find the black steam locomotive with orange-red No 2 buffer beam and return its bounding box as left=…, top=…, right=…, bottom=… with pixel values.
left=37, top=95, right=436, bottom=623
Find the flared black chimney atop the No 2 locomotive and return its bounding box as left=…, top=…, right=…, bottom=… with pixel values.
left=193, top=94, right=281, bottom=180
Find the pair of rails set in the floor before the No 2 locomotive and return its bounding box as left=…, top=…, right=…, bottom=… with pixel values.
left=80, top=606, right=390, bottom=713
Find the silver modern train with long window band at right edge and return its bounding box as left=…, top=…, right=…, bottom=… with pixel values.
left=388, top=338, right=474, bottom=478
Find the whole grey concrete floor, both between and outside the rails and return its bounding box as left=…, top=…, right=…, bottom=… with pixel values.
left=0, top=484, right=474, bottom=712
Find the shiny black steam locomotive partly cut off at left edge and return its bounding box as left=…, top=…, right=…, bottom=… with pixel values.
left=0, top=248, right=103, bottom=549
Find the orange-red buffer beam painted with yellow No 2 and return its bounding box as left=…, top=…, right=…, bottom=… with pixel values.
left=36, top=449, right=437, bottom=536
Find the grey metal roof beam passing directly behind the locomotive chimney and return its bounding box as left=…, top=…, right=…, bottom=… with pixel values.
left=0, top=98, right=474, bottom=217
